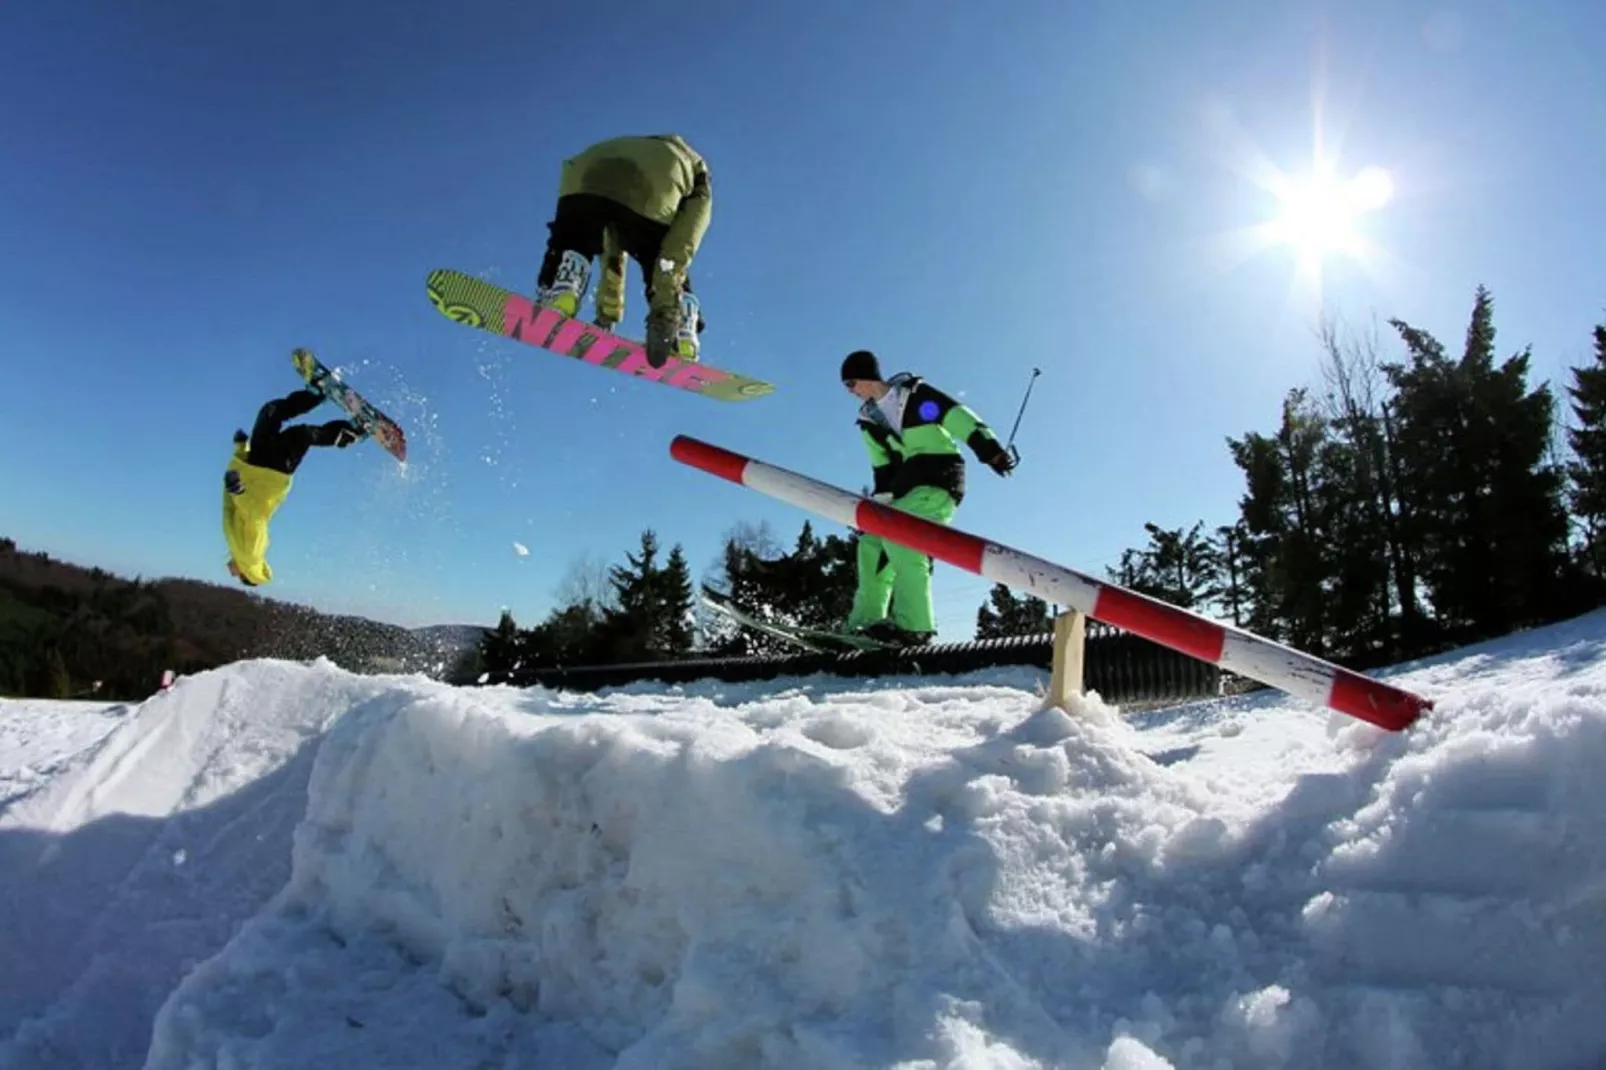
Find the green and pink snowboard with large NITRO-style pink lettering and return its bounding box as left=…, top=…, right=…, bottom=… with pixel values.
left=426, top=268, right=776, bottom=402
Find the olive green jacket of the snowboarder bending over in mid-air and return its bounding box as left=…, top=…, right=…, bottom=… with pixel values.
left=557, top=133, right=713, bottom=323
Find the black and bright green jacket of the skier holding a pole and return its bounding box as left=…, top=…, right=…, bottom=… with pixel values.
left=859, top=371, right=1004, bottom=504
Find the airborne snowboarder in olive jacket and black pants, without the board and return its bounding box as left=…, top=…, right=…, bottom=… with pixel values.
left=536, top=133, right=713, bottom=368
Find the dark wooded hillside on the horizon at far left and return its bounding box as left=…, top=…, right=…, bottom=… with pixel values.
left=0, top=538, right=483, bottom=699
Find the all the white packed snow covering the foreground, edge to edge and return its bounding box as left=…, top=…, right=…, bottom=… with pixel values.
left=0, top=614, right=1606, bottom=1070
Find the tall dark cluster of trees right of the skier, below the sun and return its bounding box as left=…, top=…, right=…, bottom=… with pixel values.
left=1108, top=286, right=1606, bottom=667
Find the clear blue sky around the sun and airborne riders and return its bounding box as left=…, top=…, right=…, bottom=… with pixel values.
left=0, top=0, right=1606, bottom=638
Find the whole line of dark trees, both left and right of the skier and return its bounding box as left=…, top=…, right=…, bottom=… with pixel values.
left=472, top=288, right=1606, bottom=673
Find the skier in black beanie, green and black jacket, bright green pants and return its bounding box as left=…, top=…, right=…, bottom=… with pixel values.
left=842, top=349, right=1015, bottom=646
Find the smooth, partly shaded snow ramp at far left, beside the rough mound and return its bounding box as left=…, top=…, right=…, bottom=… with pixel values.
left=0, top=662, right=407, bottom=1068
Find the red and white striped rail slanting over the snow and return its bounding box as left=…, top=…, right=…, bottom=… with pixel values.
left=670, top=435, right=1433, bottom=731
